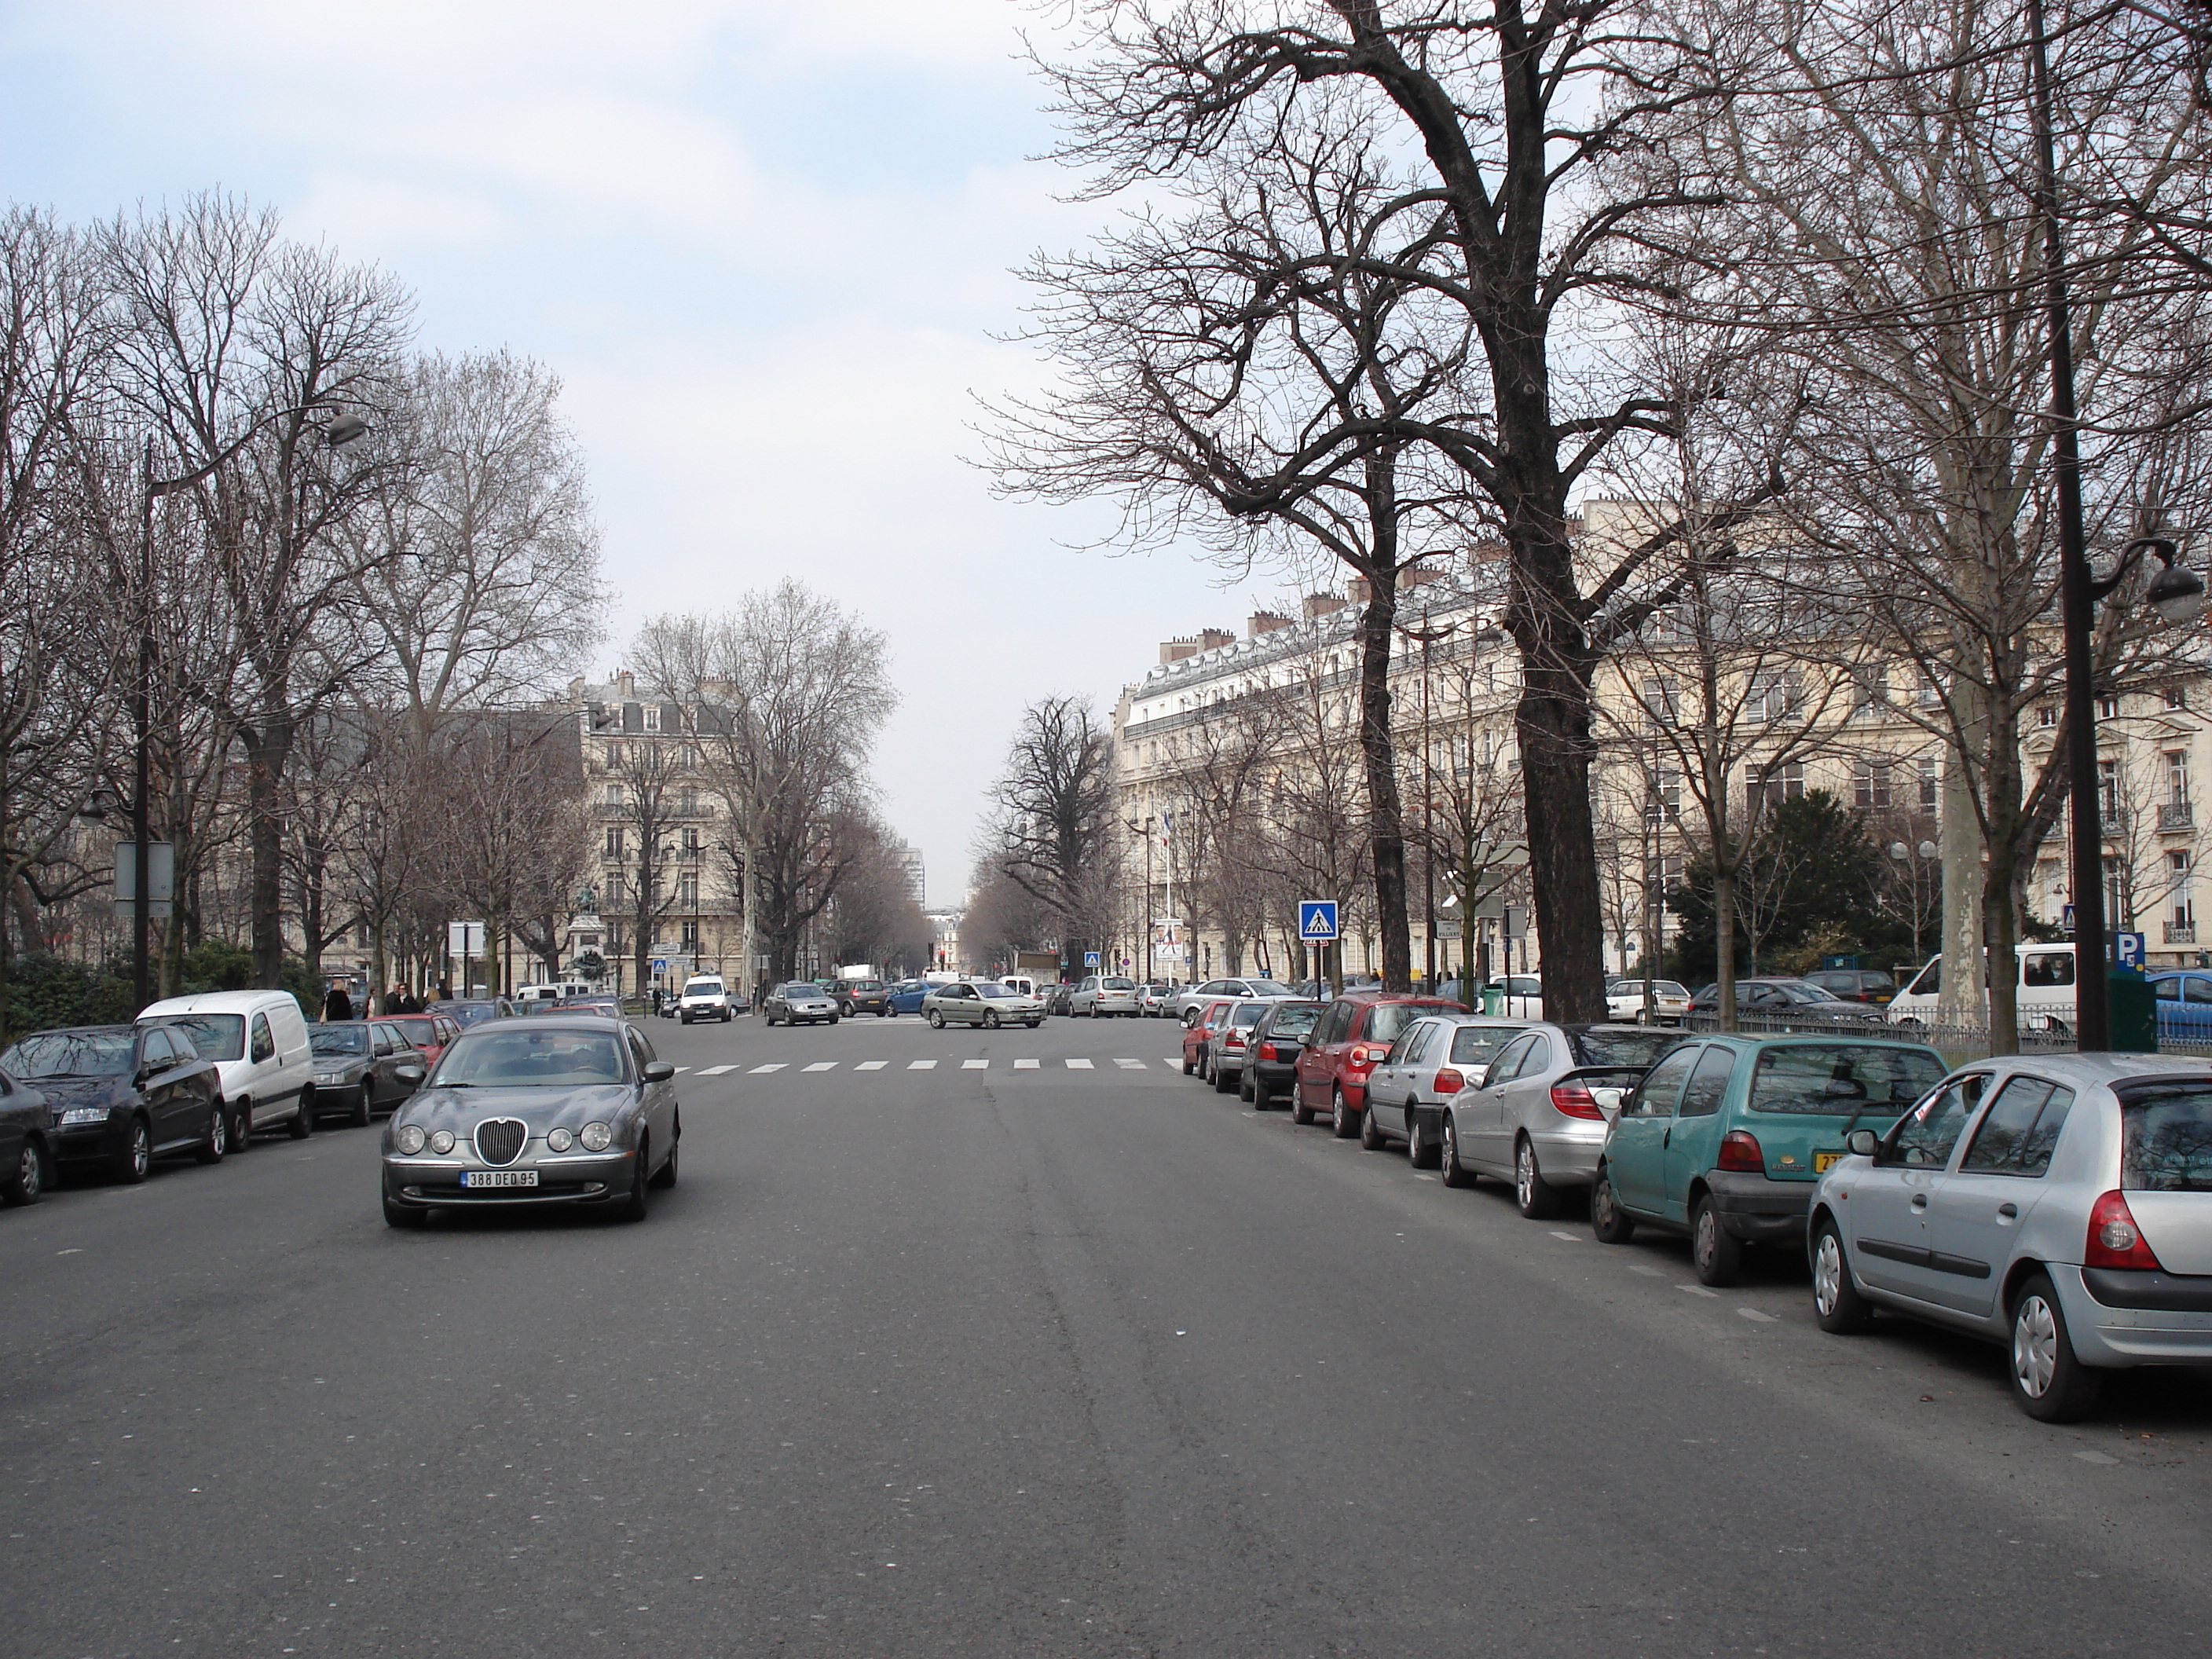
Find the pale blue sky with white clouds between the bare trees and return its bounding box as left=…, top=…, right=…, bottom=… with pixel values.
left=0, top=0, right=1283, bottom=903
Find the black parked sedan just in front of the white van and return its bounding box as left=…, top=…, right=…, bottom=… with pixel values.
left=0, top=1027, right=230, bottom=1184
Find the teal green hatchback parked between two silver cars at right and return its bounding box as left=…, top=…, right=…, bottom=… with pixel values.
left=1591, top=1035, right=1949, bottom=1285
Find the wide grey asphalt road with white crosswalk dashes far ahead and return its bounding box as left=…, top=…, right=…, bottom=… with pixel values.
left=0, top=1020, right=2212, bottom=1659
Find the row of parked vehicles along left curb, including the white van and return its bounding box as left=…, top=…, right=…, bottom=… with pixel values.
left=0, top=991, right=429, bottom=1203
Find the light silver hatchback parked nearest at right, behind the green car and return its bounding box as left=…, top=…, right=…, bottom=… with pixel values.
left=1805, top=1055, right=2212, bottom=1423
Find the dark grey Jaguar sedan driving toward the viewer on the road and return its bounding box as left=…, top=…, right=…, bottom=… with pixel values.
left=383, top=1013, right=683, bottom=1228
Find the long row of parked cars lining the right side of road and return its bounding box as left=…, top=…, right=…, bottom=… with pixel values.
left=1184, top=987, right=2212, bottom=1423
